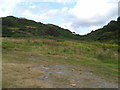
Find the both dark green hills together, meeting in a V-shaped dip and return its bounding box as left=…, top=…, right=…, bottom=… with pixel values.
left=2, top=16, right=120, bottom=43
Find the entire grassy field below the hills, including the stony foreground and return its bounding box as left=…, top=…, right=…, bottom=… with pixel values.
left=2, top=38, right=118, bottom=88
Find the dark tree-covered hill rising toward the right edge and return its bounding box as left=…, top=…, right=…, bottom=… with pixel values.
left=83, top=17, right=120, bottom=43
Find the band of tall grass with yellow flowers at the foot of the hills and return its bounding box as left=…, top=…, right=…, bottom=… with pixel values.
left=2, top=39, right=118, bottom=61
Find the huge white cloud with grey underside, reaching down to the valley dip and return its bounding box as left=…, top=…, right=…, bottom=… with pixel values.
left=59, top=0, right=119, bottom=34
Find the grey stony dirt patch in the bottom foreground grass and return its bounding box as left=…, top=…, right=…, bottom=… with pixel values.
left=28, top=64, right=118, bottom=88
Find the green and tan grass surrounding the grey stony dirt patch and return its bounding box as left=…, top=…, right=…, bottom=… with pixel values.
left=2, top=38, right=118, bottom=87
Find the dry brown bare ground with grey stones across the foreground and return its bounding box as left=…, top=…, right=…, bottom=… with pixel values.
left=3, top=52, right=118, bottom=88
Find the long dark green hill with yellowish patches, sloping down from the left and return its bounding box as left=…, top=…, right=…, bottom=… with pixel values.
left=2, top=16, right=79, bottom=39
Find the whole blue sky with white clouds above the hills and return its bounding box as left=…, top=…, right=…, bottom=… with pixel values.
left=0, top=0, right=119, bottom=35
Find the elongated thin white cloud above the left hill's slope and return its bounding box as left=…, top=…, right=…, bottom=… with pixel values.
left=22, top=7, right=68, bottom=21
